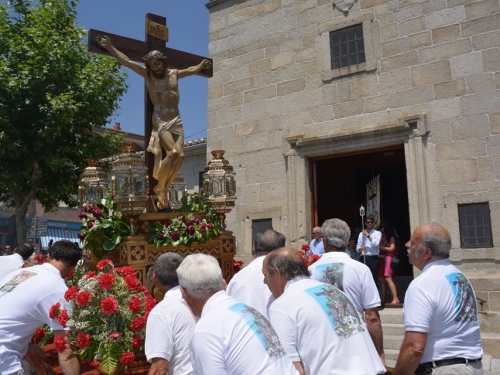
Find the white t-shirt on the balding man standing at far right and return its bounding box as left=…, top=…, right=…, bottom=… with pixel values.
left=403, top=259, right=483, bottom=363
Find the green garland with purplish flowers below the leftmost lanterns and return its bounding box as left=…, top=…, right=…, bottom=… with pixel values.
left=78, top=191, right=130, bottom=259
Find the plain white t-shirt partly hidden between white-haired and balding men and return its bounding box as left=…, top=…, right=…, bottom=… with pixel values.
left=226, top=255, right=274, bottom=318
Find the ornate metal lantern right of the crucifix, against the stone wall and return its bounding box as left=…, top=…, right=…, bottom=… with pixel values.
left=203, top=150, right=236, bottom=230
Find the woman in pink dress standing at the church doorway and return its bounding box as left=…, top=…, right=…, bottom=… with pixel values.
left=379, top=227, right=400, bottom=305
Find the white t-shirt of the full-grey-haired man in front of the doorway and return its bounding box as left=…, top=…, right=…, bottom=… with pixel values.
left=309, top=251, right=380, bottom=321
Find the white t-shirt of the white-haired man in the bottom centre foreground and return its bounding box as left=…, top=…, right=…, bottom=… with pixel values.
left=190, top=291, right=297, bottom=375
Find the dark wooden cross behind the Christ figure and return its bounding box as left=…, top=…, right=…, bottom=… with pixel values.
left=88, top=13, right=213, bottom=195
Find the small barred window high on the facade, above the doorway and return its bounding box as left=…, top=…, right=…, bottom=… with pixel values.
left=330, top=24, right=366, bottom=69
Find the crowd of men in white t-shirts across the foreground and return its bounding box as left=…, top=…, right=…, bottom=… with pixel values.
left=0, top=219, right=483, bottom=375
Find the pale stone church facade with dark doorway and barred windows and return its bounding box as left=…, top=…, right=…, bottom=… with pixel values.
left=206, top=0, right=500, bottom=354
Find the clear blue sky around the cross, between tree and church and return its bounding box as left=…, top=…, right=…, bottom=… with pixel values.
left=78, top=0, right=209, bottom=141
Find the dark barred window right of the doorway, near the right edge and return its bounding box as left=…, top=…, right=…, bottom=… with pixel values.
left=458, top=203, right=493, bottom=248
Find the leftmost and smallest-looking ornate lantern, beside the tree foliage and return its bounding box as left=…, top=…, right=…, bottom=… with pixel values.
left=78, top=159, right=111, bottom=206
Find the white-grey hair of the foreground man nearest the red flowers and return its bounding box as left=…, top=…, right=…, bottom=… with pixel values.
left=177, top=254, right=224, bottom=298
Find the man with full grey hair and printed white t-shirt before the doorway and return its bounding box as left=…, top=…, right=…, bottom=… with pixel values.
left=309, top=219, right=385, bottom=365
